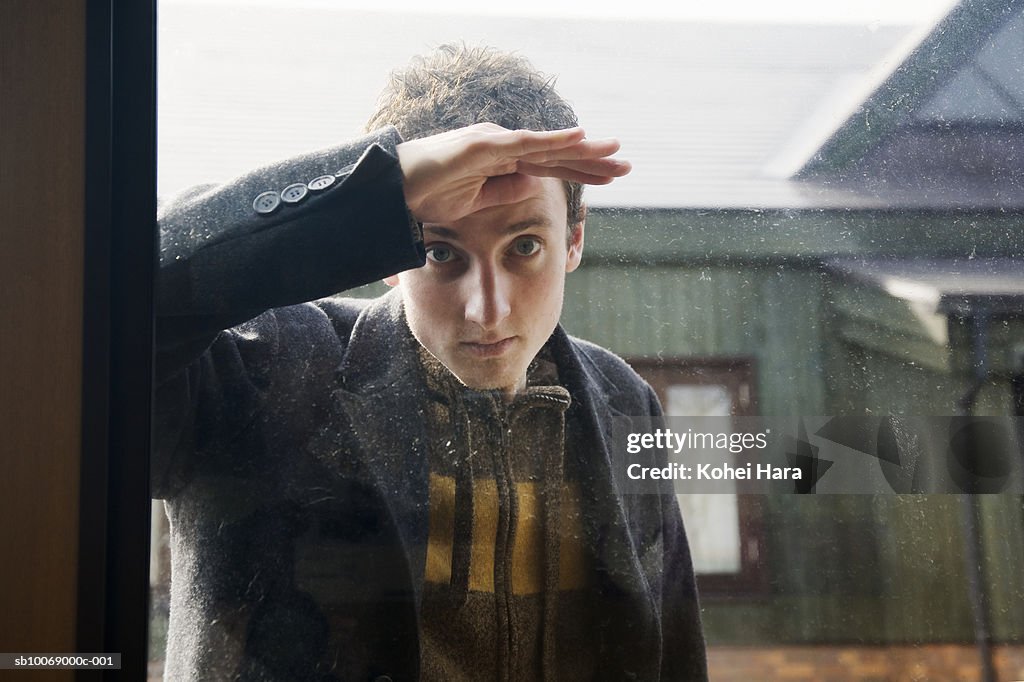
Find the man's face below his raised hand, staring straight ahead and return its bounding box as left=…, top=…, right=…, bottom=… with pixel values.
left=386, top=178, right=583, bottom=393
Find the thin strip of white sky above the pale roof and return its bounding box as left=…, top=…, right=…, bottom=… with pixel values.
left=160, top=0, right=955, bottom=25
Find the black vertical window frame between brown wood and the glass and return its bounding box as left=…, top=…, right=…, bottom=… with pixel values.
left=76, top=0, right=158, bottom=680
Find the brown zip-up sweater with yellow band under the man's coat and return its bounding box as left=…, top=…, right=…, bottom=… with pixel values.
left=420, top=349, right=595, bottom=682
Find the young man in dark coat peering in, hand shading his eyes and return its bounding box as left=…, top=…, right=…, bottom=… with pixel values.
left=154, top=47, right=707, bottom=680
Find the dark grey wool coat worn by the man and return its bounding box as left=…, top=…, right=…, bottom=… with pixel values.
left=153, top=125, right=707, bottom=680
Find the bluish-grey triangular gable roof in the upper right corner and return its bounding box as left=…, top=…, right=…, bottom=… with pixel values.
left=796, top=0, right=1024, bottom=210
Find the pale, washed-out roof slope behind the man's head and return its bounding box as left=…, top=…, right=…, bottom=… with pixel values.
left=158, top=4, right=911, bottom=209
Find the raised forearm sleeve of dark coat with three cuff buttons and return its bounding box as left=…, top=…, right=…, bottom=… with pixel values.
left=156, top=123, right=424, bottom=376
